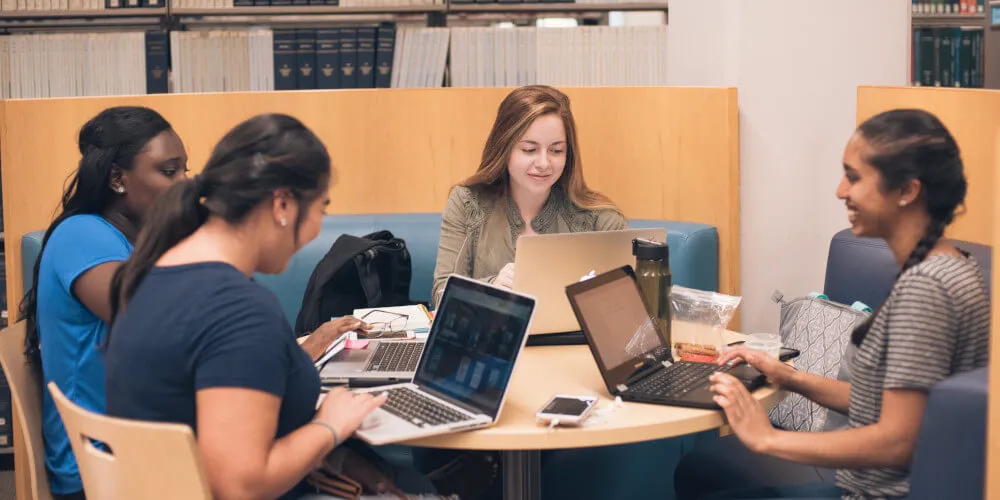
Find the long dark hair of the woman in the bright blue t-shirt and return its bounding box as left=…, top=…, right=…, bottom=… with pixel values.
left=18, top=106, right=171, bottom=368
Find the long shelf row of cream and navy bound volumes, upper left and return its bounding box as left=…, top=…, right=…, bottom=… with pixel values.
left=0, top=23, right=666, bottom=99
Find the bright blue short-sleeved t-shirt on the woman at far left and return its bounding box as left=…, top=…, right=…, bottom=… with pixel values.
left=37, top=215, right=132, bottom=494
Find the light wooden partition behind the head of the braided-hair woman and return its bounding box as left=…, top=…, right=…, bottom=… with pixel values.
left=857, top=87, right=1000, bottom=245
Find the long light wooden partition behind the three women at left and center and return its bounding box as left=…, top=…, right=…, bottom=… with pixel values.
left=0, top=87, right=740, bottom=316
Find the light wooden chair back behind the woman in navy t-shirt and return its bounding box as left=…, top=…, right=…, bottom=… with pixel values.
left=49, top=382, right=212, bottom=500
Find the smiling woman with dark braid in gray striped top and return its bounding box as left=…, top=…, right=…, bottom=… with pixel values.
left=712, top=110, right=990, bottom=498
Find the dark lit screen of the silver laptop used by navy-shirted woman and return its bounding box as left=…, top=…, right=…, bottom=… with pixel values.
left=413, top=277, right=534, bottom=417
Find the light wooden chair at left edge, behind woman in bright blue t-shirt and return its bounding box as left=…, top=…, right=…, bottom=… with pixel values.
left=0, top=321, right=52, bottom=500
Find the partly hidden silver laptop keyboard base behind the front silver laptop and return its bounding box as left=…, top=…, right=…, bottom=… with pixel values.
left=319, top=339, right=424, bottom=387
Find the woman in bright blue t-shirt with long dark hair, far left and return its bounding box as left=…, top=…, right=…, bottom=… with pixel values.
left=21, top=107, right=187, bottom=499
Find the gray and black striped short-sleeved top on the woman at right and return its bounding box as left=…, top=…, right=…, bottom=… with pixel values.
left=837, top=255, right=990, bottom=499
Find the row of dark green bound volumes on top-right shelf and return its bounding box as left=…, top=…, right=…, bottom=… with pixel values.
left=911, top=28, right=984, bottom=88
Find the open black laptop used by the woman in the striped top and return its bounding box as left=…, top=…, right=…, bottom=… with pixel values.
left=566, top=266, right=766, bottom=409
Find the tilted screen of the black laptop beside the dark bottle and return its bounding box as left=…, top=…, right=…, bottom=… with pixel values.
left=571, top=269, right=666, bottom=373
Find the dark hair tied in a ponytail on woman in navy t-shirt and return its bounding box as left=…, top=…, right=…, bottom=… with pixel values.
left=109, top=114, right=330, bottom=324
